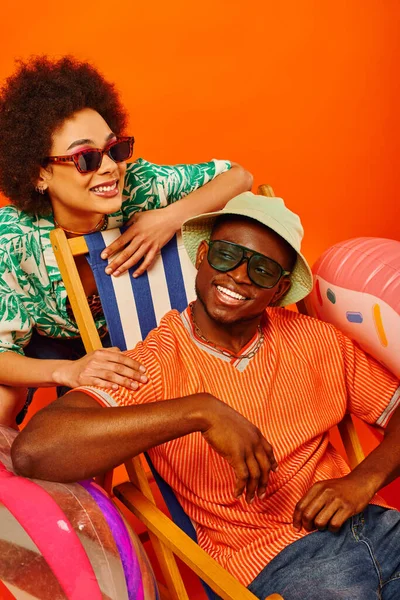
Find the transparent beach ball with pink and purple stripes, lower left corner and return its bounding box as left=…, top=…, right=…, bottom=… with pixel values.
left=0, top=427, right=159, bottom=600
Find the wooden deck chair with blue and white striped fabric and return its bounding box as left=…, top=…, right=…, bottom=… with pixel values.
left=50, top=189, right=283, bottom=600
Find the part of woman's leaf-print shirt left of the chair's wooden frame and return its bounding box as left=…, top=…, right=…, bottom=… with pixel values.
left=0, top=206, right=83, bottom=355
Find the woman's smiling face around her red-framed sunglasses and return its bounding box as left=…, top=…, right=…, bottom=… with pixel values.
left=38, top=108, right=126, bottom=231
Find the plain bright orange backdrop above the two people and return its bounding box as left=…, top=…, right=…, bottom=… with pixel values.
left=0, top=0, right=400, bottom=500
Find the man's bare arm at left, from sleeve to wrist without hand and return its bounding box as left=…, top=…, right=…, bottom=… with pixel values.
left=11, top=392, right=207, bottom=481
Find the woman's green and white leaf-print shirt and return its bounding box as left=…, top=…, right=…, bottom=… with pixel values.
left=0, top=159, right=230, bottom=355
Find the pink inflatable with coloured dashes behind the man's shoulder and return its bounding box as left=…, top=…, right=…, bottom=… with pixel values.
left=307, top=238, right=400, bottom=377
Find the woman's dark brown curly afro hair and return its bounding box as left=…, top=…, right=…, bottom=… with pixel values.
left=0, top=56, right=126, bottom=214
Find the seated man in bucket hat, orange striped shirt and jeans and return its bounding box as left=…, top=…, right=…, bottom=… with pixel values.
left=12, top=193, right=400, bottom=600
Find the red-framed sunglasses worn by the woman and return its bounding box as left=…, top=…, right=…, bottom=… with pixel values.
left=44, top=137, right=135, bottom=173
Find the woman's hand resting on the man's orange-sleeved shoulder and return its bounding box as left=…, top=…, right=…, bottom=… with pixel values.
left=53, top=348, right=147, bottom=390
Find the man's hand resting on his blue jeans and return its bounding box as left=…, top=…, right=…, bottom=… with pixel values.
left=293, top=472, right=375, bottom=532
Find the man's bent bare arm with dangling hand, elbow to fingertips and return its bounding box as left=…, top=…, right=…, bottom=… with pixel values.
left=11, top=391, right=276, bottom=502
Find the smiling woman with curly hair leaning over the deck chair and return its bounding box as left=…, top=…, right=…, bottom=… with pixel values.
left=0, top=57, right=252, bottom=425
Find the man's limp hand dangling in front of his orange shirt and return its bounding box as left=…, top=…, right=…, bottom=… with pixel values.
left=202, top=398, right=278, bottom=504
